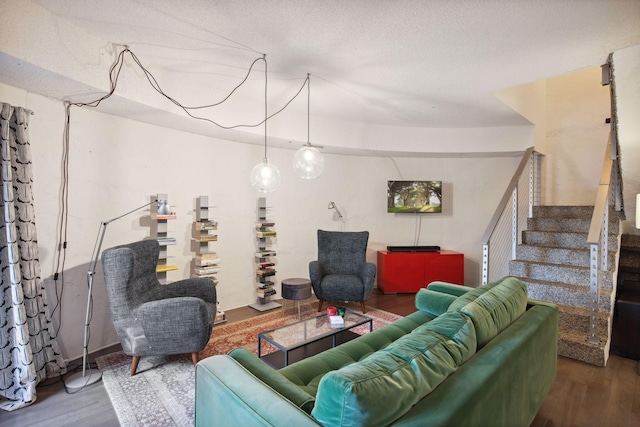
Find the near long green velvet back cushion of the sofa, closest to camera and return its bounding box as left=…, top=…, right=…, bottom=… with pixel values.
left=311, top=312, right=476, bottom=426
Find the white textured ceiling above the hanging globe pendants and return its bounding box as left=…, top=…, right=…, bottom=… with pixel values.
left=20, top=0, right=640, bottom=128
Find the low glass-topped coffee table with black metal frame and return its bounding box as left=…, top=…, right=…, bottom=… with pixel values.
left=258, top=310, right=373, bottom=369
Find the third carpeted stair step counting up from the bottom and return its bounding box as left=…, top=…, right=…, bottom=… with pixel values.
left=514, top=275, right=612, bottom=313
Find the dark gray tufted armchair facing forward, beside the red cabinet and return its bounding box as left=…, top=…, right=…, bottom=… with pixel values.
left=309, top=230, right=376, bottom=313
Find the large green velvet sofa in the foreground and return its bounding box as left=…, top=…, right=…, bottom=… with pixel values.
left=195, top=277, right=558, bottom=426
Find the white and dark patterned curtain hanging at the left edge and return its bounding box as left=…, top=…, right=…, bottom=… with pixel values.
left=0, top=103, right=66, bottom=412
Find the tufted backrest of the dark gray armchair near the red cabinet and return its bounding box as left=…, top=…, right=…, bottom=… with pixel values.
left=318, top=230, right=369, bottom=274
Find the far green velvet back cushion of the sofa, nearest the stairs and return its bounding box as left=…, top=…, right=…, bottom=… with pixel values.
left=458, top=277, right=527, bottom=348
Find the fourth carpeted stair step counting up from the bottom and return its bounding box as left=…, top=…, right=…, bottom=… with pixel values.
left=509, top=259, right=613, bottom=289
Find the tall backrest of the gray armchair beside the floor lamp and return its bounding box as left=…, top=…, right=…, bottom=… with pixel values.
left=102, top=240, right=160, bottom=322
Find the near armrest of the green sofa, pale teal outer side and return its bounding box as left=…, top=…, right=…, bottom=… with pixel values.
left=195, top=355, right=319, bottom=427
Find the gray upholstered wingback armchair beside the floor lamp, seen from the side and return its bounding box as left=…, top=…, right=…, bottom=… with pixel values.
left=102, top=240, right=216, bottom=375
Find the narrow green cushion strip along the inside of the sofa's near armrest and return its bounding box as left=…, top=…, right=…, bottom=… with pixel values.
left=229, top=347, right=315, bottom=414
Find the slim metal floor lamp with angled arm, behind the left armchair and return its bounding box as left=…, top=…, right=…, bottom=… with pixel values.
left=64, top=199, right=161, bottom=392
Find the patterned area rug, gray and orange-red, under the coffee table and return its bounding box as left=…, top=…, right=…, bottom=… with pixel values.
left=96, top=309, right=402, bottom=427
